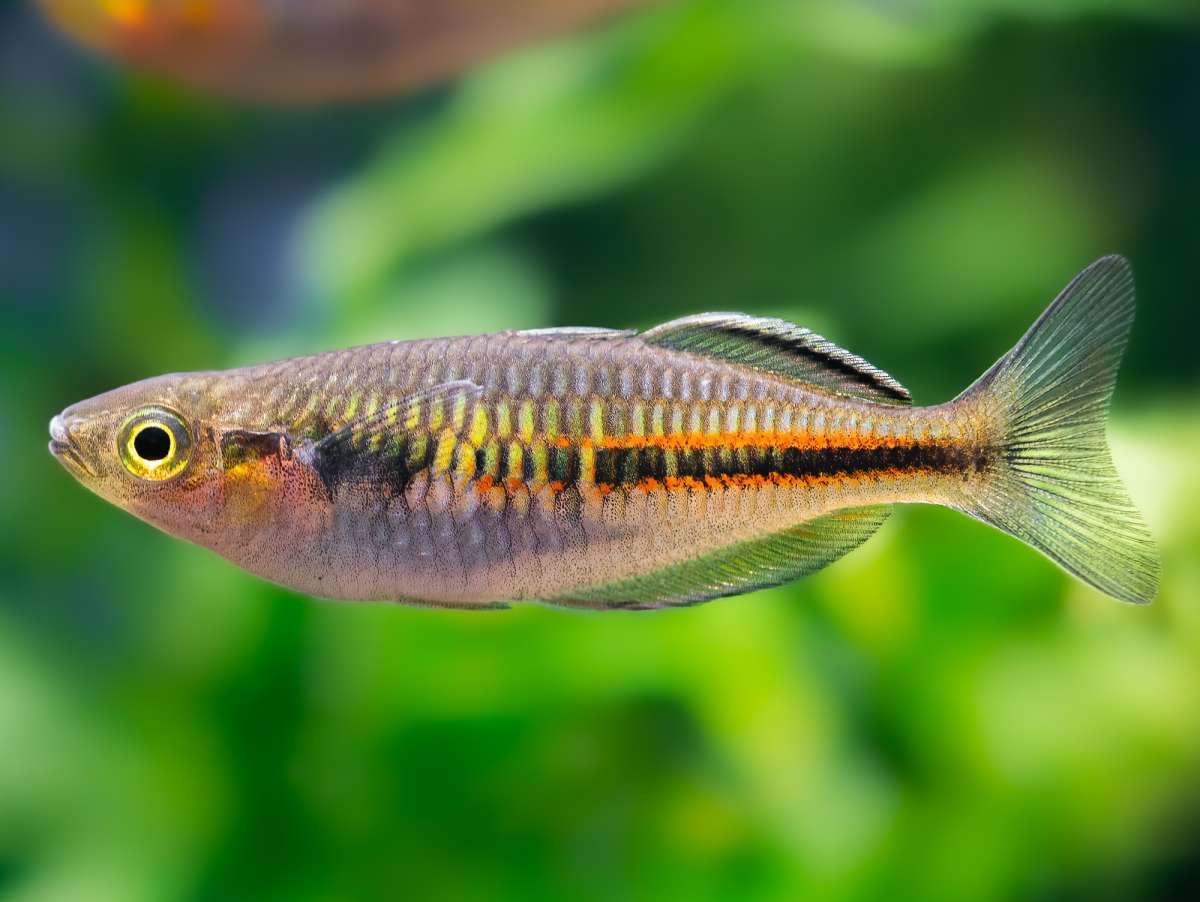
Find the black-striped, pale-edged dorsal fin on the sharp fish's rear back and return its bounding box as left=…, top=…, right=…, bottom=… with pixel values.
left=642, top=313, right=912, bottom=404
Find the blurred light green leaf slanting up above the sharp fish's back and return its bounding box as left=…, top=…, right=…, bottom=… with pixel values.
left=301, top=2, right=770, bottom=302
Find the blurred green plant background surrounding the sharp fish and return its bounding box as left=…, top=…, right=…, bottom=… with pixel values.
left=0, top=0, right=1200, bottom=901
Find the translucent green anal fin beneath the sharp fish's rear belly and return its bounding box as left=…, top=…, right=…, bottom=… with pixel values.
left=547, top=505, right=892, bottom=611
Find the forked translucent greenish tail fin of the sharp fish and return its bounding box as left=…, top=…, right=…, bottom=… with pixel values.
left=958, top=257, right=1159, bottom=603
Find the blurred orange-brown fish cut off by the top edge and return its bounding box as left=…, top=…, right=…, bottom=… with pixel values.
left=38, top=0, right=649, bottom=103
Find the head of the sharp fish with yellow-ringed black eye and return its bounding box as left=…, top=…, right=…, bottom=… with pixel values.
left=49, top=373, right=246, bottom=541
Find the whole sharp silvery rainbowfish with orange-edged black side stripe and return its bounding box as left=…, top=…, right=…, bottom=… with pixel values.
left=50, top=257, right=1158, bottom=608
